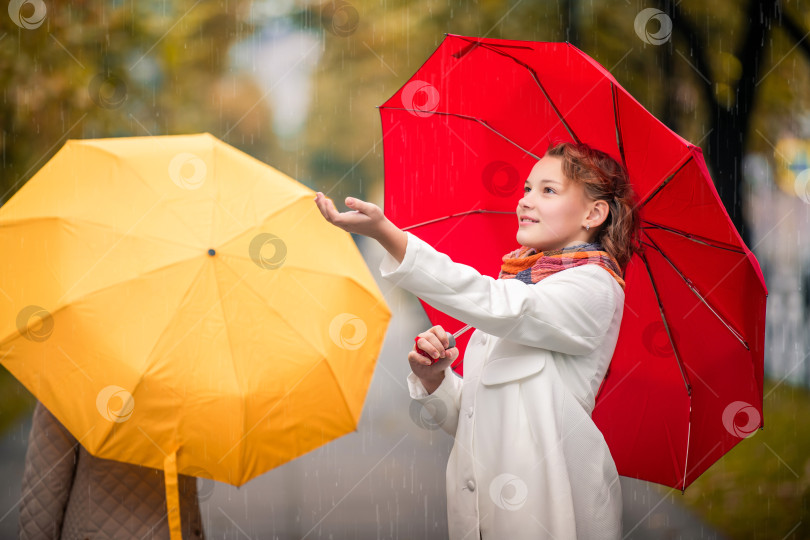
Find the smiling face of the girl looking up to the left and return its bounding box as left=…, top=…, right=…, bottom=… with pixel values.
left=516, top=156, right=607, bottom=251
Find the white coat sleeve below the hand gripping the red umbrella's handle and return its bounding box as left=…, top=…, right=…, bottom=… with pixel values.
left=408, top=367, right=462, bottom=436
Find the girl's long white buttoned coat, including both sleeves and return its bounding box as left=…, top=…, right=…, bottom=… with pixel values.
left=380, top=232, right=624, bottom=540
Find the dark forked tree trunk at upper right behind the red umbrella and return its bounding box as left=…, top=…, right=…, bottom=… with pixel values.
left=660, top=0, right=810, bottom=245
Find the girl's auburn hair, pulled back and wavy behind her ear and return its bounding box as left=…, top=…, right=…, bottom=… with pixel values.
left=545, top=141, right=640, bottom=272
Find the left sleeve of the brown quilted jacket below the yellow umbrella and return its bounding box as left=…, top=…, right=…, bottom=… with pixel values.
left=19, top=402, right=78, bottom=539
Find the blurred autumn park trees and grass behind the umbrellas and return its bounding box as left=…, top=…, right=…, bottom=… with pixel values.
left=0, top=0, right=810, bottom=538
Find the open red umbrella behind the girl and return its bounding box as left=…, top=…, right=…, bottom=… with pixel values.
left=380, top=34, right=767, bottom=490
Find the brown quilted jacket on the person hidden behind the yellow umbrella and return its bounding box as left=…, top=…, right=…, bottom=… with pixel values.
left=19, top=402, right=204, bottom=540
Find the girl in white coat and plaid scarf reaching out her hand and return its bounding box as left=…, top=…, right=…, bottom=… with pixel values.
left=315, top=143, right=638, bottom=540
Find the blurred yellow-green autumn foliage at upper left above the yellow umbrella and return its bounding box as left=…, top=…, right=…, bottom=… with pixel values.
left=0, top=0, right=274, bottom=207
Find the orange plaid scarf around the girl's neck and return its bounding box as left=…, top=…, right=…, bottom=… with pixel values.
left=498, top=243, right=624, bottom=290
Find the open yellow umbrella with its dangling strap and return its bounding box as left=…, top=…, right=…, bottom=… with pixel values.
left=0, top=133, right=391, bottom=537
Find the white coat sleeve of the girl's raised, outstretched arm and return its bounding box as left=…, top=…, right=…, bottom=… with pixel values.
left=380, top=232, right=623, bottom=355
